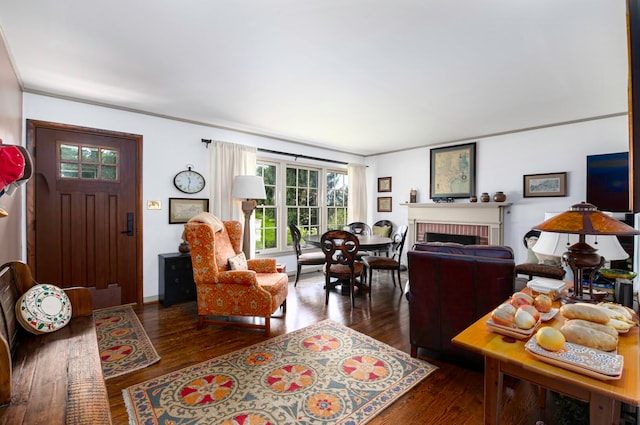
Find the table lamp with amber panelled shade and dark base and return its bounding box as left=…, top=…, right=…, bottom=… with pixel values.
left=533, top=202, right=640, bottom=302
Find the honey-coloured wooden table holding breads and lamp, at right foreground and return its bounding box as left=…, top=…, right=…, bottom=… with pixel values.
left=452, top=294, right=640, bottom=425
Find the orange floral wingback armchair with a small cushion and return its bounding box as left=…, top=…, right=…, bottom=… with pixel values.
left=184, top=221, right=289, bottom=336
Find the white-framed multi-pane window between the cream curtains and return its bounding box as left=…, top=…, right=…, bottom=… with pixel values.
left=255, top=158, right=348, bottom=254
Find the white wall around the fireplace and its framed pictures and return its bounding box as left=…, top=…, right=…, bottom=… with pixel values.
left=366, top=116, right=629, bottom=261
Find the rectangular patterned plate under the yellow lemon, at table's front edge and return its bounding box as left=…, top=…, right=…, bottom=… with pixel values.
left=524, top=338, right=624, bottom=379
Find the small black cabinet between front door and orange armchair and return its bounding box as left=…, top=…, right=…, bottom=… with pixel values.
left=158, top=252, right=196, bottom=307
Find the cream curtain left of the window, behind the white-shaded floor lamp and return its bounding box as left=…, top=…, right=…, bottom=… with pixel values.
left=209, top=140, right=256, bottom=258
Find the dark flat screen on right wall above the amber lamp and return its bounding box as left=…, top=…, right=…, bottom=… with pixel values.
left=587, top=152, right=629, bottom=212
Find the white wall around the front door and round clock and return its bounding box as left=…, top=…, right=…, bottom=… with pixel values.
left=23, top=93, right=364, bottom=301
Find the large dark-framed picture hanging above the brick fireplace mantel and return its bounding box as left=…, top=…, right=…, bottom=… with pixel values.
left=430, top=143, right=476, bottom=199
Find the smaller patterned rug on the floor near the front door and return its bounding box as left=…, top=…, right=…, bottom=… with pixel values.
left=93, top=306, right=160, bottom=379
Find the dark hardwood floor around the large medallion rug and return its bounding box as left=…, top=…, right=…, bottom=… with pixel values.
left=106, top=272, right=552, bottom=424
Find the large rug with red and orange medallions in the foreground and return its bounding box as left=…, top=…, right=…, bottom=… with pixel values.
left=122, top=320, right=436, bottom=425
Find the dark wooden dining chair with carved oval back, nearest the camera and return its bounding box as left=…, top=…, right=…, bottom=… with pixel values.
left=320, top=230, right=364, bottom=307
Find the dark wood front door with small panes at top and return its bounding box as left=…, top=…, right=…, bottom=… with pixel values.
left=27, top=120, right=142, bottom=308
